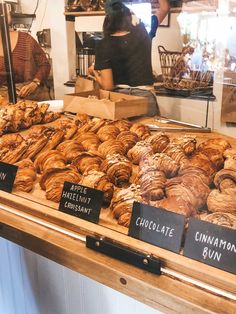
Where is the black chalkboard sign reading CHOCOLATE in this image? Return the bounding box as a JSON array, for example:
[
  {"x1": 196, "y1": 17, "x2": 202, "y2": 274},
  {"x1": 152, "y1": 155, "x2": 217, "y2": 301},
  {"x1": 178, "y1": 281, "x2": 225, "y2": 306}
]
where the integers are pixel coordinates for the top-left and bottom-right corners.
[{"x1": 128, "y1": 202, "x2": 185, "y2": 253}]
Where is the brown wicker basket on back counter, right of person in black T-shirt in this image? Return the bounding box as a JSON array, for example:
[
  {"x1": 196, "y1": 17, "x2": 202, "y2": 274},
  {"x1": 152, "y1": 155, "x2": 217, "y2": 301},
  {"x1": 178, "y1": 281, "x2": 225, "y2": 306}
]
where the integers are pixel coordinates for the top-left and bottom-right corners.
[{"x1": 158, "y1": 46, "x2": 213, "y2": 90}]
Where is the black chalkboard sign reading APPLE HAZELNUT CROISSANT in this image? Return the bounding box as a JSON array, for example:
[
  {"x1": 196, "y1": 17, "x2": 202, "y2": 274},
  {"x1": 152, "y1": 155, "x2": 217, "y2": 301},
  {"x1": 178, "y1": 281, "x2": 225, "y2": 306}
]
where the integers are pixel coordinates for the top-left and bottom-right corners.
[{"x1": 59, "y1": 181, "x2": 103, "y2": 223}]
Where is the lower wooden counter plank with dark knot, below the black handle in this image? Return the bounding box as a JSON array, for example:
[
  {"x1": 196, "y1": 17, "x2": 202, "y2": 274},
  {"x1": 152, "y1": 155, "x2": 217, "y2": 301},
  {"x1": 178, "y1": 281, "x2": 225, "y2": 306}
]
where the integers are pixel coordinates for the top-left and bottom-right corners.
[{"x1": 0, "y1": 206, "x2": 236, "y2": 314}]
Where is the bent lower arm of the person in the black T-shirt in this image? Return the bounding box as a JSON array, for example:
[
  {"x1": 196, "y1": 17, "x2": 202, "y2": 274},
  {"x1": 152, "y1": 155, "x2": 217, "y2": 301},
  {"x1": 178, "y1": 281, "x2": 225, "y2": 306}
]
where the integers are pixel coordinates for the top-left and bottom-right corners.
[{"x1": 88, "y1": 65, "x2": 114, "y2": 90}]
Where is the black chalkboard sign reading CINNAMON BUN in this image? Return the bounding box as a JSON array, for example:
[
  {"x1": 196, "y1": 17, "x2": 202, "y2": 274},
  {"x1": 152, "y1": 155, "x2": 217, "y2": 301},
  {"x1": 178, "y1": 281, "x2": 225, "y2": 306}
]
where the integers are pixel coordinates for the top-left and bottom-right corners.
[{"x1": 184, "y1": 218, "x2": 236, "y2": 274}]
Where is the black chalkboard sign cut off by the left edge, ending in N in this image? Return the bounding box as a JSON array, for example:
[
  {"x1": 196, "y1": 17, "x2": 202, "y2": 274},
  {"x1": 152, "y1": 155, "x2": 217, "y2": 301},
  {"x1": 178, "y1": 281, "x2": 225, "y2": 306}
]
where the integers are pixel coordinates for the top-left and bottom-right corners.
[{"x1": 0, "y1": 162, "x2": 18, "y2": 192}]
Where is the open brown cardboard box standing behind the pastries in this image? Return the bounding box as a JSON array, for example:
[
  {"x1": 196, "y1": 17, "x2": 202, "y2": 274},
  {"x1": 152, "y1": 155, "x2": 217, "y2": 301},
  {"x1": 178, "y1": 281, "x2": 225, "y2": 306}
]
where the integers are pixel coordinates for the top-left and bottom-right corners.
[{"x1": 64, "y1": 89, "x2": 148, "y2": 120}]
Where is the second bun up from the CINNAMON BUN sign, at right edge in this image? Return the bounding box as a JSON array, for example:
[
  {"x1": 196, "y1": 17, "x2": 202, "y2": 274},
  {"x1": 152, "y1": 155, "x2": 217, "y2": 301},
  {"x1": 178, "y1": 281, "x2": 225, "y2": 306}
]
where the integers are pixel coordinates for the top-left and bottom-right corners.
[{"x1": 207, "y1": 189, "x2": 236, "y2": 214}]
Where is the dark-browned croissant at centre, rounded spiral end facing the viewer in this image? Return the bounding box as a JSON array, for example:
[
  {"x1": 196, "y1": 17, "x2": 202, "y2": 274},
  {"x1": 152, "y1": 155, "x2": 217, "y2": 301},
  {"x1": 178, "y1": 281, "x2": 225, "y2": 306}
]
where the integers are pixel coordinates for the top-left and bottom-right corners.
[{"x1": 101, "y1": 154, "x2": 132, "y2": 187}]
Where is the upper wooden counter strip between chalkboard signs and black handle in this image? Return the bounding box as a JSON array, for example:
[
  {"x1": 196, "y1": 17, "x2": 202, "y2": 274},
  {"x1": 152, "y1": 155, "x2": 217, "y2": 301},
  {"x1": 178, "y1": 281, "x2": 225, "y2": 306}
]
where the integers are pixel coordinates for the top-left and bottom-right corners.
[{"x1": 0, "y1": 191, "x2": 236, "y2": 293}]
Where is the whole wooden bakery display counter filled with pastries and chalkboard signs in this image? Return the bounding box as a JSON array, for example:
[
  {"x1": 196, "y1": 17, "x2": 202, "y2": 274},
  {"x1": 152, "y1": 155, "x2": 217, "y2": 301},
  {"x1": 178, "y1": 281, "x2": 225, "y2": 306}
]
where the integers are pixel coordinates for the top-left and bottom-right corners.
[{"x1": 0, "y1": 1, "x2": 236, "y2": 313}]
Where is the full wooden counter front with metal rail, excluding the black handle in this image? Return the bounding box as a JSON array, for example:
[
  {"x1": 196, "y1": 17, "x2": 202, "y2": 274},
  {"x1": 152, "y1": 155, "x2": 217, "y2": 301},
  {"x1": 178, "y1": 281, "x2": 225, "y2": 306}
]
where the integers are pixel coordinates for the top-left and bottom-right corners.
[{"x1": 0, "y1": 118, "x2": 236, "y2": 314}]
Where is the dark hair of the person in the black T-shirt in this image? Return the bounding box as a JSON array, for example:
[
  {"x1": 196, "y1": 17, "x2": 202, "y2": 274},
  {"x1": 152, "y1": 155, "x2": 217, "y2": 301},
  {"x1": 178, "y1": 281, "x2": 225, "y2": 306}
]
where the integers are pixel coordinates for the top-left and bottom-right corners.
[{"x1": 103, "y1": 2, "x2": 132, "y2": 36}]
